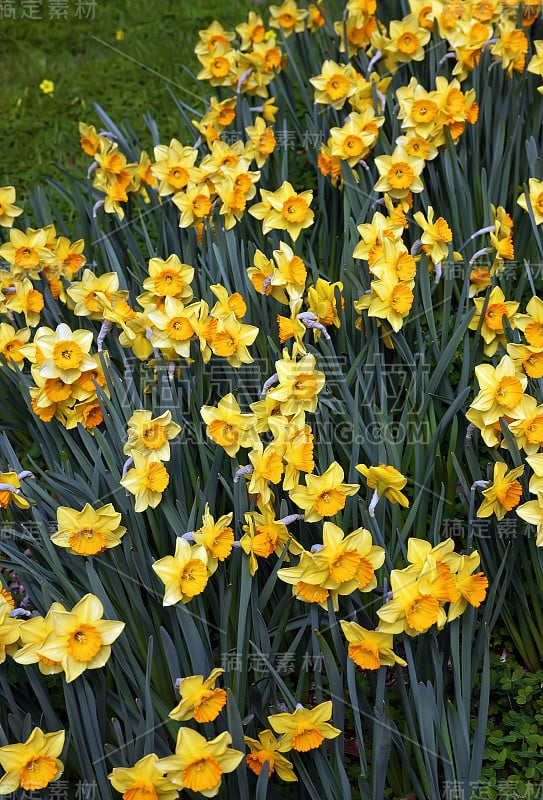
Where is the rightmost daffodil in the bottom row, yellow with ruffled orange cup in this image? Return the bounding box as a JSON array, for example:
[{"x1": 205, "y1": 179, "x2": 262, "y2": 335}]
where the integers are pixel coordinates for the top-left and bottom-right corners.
[{"x1": 268, "y1": 700, "x2": 341, "y2": 753}]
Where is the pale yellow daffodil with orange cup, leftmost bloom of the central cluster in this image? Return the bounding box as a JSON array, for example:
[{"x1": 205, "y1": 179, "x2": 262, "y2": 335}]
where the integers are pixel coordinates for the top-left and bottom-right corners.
[{"x1": 200, "y1": 394, "x2": 258, "y2": 456}]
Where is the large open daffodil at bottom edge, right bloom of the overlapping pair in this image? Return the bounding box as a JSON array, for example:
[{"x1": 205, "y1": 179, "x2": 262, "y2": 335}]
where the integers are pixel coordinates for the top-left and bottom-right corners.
[{"x1": 158, "y1": 728, "x2": 244, "y2": 797}]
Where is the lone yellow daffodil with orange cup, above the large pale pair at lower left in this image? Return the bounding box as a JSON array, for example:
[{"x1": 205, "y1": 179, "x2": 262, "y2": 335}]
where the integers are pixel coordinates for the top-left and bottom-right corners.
[{"x1": 51, "y1": 503, "x2": 126, "y2": 556}]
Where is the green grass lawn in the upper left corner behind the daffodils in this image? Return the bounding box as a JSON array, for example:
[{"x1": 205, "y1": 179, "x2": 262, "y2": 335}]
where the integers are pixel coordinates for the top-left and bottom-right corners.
[{"x1": 0, "y1": 0, "x2": 252, "y2": 200}]
